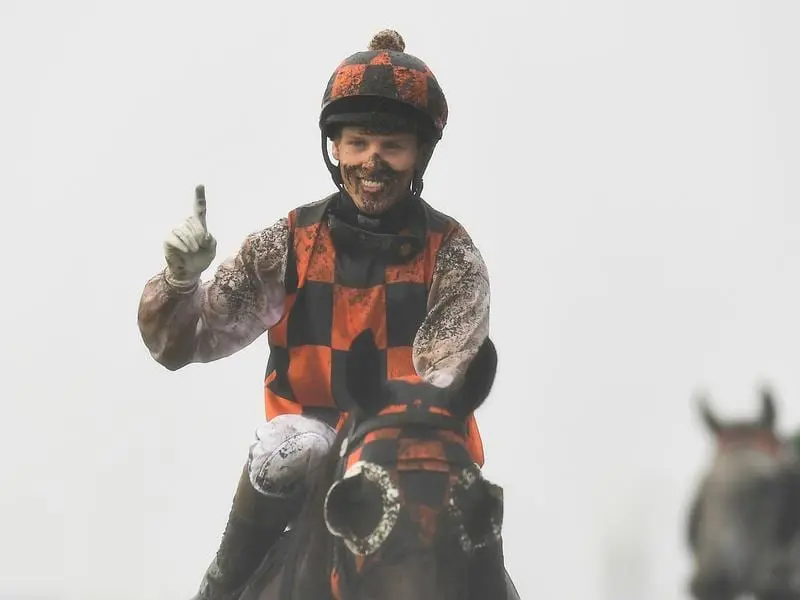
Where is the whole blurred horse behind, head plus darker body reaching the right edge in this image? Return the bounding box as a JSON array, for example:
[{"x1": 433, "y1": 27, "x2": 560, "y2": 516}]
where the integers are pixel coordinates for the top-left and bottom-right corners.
[{"x1": 688, "y1": 388, "x2": 800, "y2": 600}]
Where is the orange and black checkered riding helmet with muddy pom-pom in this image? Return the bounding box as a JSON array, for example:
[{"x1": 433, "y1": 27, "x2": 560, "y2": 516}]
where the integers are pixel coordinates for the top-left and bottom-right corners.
[{"x1": 319, "y1": 30, "x2": 447, "y2": 190}]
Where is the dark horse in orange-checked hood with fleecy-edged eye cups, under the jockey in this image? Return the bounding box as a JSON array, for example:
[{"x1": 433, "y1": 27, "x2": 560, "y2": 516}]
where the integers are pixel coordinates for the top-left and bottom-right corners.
[{"x1": 239, "y1": 330, "x2": 519, "y2": 600}]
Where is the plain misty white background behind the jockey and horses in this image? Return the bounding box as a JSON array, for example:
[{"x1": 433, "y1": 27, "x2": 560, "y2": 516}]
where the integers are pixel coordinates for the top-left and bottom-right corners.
[{"x1": 0, "y1": 0, "x2": 800, "y2": 600}]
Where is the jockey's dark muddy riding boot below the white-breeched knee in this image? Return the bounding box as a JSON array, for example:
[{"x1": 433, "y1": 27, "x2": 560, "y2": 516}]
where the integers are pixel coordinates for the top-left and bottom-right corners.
[{"x1": 192, "y1": 467, "x2": 296, "y2": 600}]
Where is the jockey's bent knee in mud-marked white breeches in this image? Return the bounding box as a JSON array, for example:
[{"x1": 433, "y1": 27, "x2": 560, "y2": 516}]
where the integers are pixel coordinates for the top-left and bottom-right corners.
[{"x1": 247, "y1": 415, "x2": 336, "y2": 497}]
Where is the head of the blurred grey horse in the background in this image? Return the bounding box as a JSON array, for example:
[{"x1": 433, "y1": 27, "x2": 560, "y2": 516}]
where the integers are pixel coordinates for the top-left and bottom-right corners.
[{"x1": 688, "y1": 388, "x2": 785, "y2": 600}]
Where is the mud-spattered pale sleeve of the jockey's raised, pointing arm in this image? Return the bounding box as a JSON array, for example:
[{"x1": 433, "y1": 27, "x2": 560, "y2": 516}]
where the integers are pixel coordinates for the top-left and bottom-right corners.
[{"x1": 138, "y1": 218, "x2": 288, "y2": 371}]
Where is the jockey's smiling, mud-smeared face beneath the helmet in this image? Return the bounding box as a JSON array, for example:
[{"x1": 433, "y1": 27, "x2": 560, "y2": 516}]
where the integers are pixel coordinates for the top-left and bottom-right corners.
[{"x1": 333, "y1": 126, "x2": 420, "y2": 215}]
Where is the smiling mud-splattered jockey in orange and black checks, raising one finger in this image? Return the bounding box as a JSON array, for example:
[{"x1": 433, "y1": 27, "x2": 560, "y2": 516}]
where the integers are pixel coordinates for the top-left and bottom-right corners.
[{"x1": 138, "y1": 30, "x2": 489, "y2": 600}]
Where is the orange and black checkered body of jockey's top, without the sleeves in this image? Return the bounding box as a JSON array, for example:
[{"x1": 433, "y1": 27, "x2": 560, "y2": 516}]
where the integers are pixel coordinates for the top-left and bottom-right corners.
[{"x1": 264, "y1": 196, "x2": 484, "y2": 465}]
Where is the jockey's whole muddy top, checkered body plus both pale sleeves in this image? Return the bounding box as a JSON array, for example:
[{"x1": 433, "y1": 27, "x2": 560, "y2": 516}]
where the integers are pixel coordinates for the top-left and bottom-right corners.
[{"x1": 139, "y1": 196, "x2": 489, "y2": 465}]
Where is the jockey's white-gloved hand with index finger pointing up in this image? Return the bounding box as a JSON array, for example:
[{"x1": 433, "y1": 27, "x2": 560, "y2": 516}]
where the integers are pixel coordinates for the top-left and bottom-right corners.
[{"x1": 164, "y1": 185, "x2": 217, "y2": 289}]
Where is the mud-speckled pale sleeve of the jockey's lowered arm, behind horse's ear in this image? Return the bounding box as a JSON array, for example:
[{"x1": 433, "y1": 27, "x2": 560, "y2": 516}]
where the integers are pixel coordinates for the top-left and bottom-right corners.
[{"x1": 413, "y1": 227, "x2": 489, "y2": 386}]
